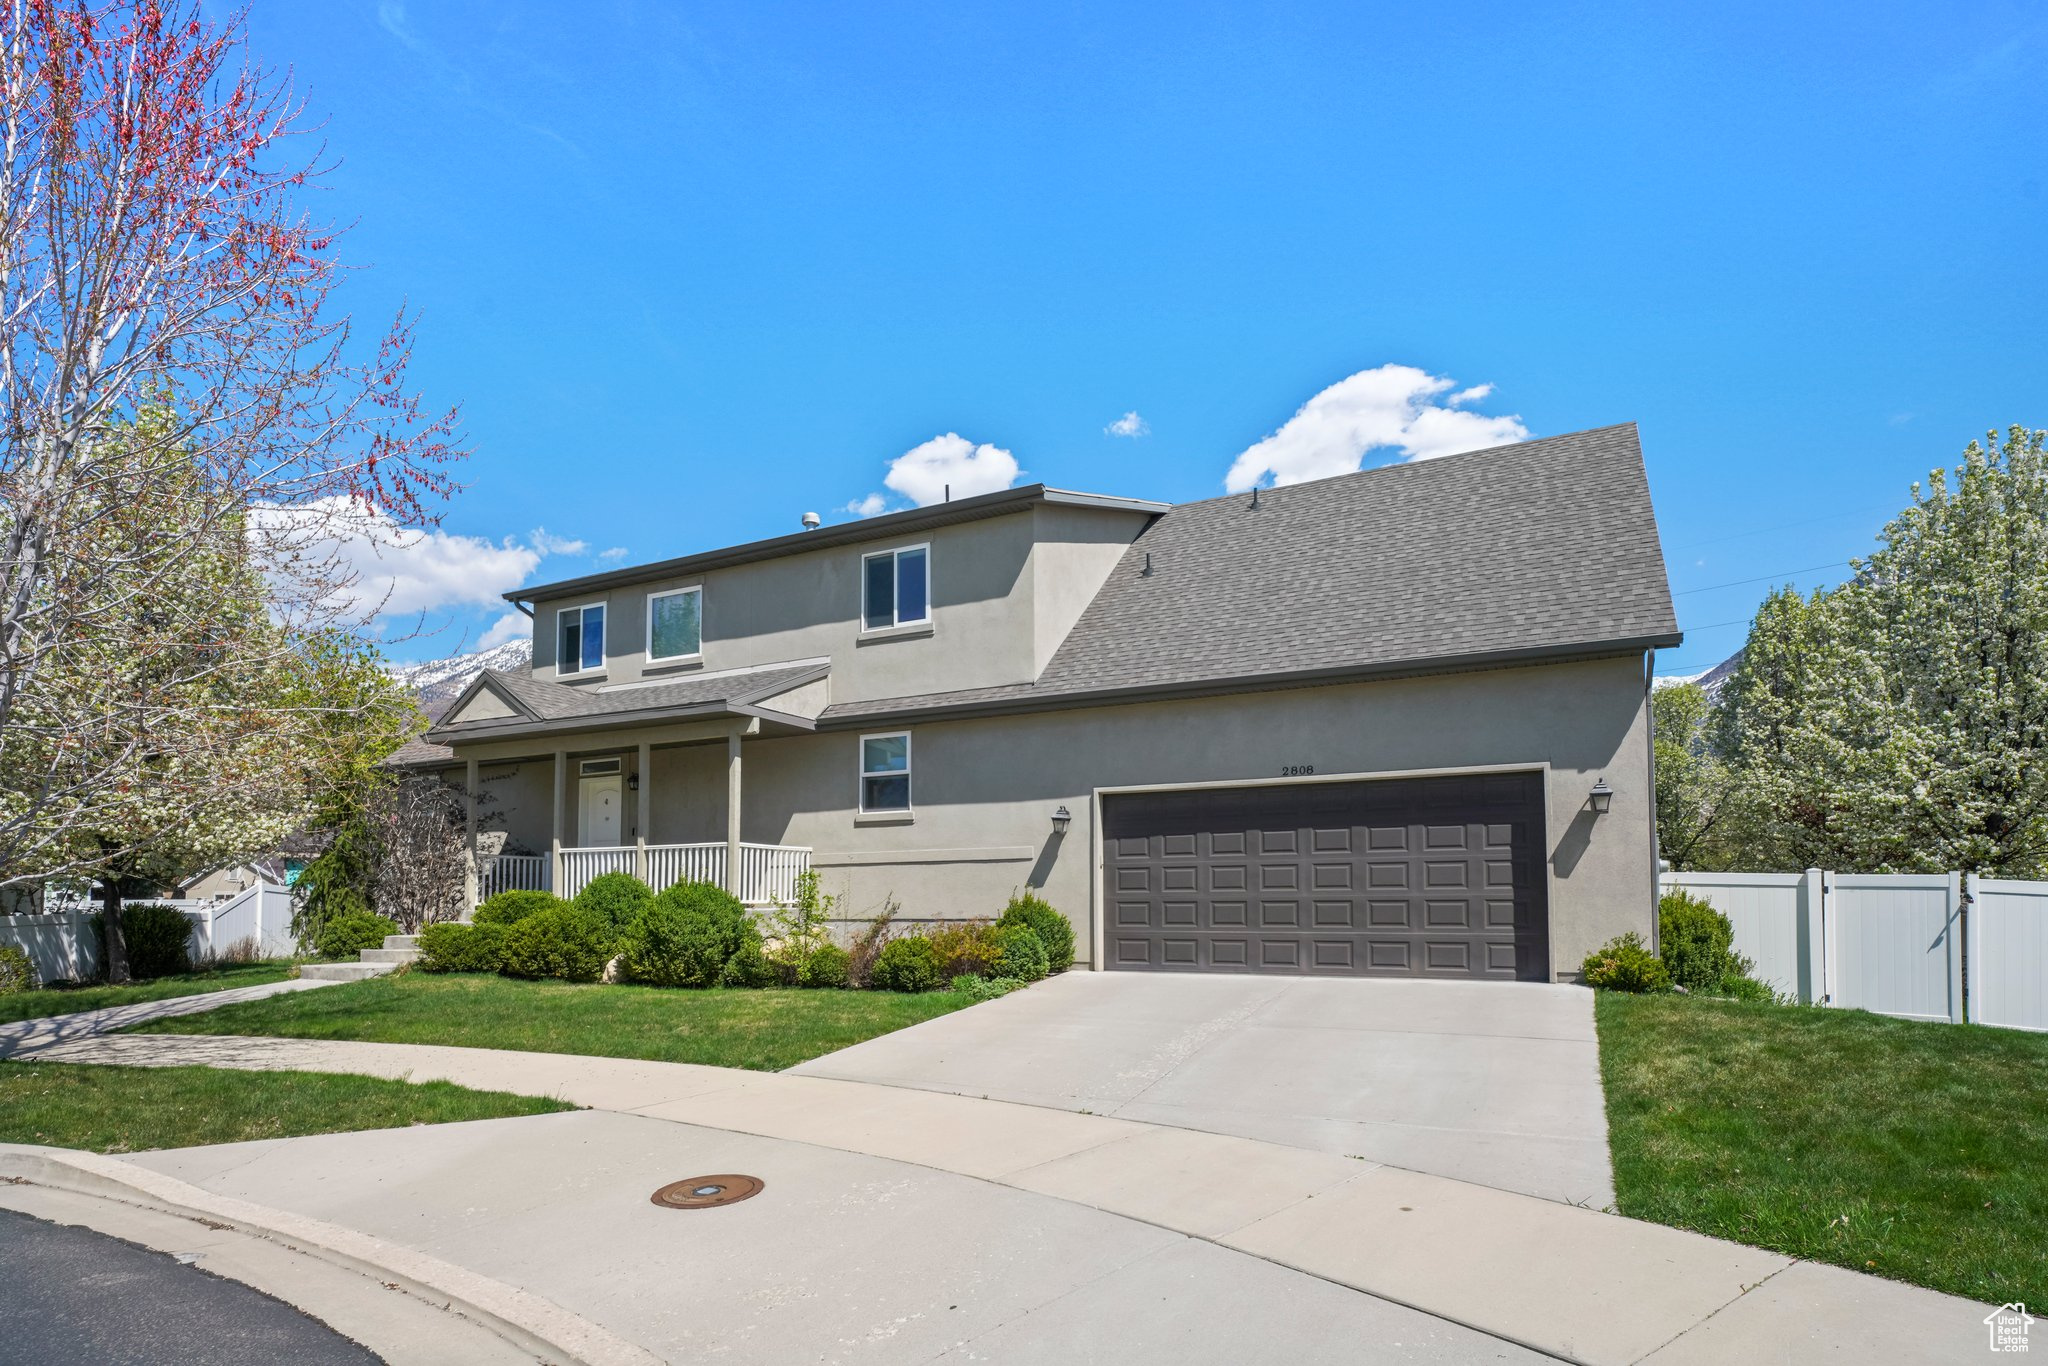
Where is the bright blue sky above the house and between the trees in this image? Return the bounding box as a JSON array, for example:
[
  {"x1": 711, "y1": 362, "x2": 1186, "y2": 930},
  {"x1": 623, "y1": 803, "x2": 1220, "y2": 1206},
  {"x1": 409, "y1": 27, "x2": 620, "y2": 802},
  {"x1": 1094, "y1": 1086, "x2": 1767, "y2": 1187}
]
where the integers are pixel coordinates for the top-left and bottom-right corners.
[{"x1": 252, "y1": 0, "x2": 2048, "y2": 672}]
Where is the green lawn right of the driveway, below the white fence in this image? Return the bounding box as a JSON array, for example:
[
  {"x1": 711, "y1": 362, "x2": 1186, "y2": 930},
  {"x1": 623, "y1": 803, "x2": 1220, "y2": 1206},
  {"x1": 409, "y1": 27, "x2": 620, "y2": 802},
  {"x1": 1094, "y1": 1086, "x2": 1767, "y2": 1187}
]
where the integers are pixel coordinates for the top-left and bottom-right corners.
[{"x1": 1595, "y1": 991, "x2": 2048, "y2": 1305}]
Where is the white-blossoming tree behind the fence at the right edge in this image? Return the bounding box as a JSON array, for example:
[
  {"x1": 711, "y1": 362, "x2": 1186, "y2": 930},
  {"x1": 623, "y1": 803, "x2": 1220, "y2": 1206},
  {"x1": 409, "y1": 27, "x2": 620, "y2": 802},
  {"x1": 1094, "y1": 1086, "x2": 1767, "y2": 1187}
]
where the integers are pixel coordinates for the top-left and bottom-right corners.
[{"x1": 1718, "y1": 426, "x2": 2048, "y2": 877}]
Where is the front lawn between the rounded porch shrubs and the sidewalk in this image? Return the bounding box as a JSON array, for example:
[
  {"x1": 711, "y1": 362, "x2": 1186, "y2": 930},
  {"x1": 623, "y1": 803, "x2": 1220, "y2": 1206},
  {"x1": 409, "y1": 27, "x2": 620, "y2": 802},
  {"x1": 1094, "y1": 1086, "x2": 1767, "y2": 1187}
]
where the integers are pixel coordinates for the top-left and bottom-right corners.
[{"x1": 137, "y1": 973, "x2": 973, "y2": 1071}]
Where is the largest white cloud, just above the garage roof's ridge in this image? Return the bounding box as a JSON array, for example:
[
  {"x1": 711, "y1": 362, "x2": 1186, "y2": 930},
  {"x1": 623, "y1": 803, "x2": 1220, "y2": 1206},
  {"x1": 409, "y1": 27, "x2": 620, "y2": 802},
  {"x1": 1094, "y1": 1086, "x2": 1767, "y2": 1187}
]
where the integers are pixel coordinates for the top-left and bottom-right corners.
[{"x1": 1223, "y1": 365, "x2": 1530, "y2": 494}]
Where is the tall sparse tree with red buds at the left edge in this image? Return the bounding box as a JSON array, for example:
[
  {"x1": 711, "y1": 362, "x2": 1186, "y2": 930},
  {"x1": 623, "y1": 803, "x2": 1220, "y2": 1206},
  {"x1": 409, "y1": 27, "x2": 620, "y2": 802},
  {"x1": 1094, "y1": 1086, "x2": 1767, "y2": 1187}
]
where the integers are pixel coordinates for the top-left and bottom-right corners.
[{"x1": 0, "y1": 0, "x2": 461, "y2": 970}]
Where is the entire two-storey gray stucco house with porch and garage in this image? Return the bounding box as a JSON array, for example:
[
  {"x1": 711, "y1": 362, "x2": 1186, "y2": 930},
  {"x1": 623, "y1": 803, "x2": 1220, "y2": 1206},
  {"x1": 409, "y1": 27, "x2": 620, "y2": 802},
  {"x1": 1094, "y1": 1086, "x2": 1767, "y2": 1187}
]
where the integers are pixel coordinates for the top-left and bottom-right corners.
[{"x1": 399, "y1": 426, "x2": 1679, "y2": 981}]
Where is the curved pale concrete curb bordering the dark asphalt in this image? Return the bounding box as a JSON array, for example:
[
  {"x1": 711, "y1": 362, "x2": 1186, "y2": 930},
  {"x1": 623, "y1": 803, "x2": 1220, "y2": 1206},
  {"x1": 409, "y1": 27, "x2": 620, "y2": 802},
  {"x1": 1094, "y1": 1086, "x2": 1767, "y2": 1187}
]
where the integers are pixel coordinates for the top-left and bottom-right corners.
[{"x1": 0, "y1": 1143, "x2": 662, "y2": 1366}]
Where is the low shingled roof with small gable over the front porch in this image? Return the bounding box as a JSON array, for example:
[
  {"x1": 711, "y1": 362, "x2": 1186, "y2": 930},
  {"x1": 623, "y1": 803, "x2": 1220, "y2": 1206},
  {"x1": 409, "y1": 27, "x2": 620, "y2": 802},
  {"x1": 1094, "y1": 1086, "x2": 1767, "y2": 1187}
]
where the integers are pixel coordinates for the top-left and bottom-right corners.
[{"x1": 423, "y1": 659, "x2": 831, "y2": 749}]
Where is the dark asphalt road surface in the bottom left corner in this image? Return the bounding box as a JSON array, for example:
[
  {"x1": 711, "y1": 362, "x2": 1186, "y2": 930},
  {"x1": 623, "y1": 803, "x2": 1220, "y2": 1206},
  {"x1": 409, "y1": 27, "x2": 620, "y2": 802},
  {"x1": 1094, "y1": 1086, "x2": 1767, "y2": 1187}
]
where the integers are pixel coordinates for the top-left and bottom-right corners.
[{"x1": 0, "y1": 1210, "x2": 383, "y2": 1366}]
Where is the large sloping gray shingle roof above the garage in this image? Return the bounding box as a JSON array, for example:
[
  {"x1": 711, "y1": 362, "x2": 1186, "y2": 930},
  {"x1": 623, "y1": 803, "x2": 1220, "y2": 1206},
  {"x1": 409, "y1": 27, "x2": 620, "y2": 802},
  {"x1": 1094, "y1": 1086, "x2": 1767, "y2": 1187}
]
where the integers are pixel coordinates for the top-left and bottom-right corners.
[{"x1": 819, "y1": 424, "x2": 1679, "y2": 723}]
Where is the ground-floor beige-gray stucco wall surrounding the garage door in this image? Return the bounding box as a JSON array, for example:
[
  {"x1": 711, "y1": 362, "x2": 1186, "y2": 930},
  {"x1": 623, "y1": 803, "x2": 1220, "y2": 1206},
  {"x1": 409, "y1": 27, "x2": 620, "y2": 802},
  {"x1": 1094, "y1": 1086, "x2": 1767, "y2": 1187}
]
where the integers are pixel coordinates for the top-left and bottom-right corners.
[{"x1": 456, "y1": 655, "x2": 1653, "y2": 977}]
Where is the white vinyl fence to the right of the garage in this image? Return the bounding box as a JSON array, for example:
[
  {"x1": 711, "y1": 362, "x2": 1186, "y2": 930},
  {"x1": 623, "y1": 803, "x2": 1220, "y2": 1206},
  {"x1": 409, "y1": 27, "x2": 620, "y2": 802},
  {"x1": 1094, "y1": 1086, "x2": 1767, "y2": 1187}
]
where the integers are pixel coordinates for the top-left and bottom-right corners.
[{"x1": 1663, "y1": 868, "x2": 2048, "y2": 1030}]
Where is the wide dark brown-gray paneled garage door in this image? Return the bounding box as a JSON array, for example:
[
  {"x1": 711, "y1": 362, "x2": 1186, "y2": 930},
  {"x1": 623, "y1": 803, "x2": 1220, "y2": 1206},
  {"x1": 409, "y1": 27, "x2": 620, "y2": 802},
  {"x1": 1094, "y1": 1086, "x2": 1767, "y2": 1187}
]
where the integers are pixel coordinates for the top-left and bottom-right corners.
[{"x1": 1102, "y1": 774, "x2": 1550, "y2": 981}]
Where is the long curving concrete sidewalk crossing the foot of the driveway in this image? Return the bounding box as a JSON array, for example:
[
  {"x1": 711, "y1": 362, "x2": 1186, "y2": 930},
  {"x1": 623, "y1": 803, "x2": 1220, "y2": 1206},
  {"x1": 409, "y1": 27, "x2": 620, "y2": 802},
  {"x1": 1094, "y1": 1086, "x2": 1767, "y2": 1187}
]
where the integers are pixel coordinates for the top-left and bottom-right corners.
[{"x1": 19, "y1": 1036, "x2": 1985, "y2": 1366}]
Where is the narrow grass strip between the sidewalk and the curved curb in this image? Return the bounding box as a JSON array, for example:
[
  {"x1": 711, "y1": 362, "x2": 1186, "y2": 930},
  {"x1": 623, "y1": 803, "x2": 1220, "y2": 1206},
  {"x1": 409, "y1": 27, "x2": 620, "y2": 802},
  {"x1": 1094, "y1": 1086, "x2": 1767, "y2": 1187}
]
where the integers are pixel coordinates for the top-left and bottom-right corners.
[{"x1": 0, "y1": 1063, "x2": 575, "y2": 1153}]
